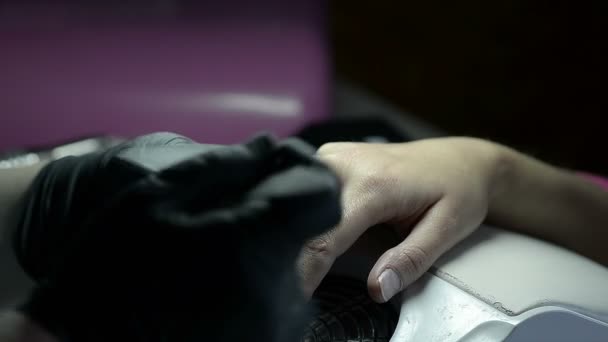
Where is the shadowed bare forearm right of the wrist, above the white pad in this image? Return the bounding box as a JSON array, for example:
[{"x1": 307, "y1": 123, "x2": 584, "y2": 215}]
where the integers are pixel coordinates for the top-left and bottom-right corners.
[{"x1": 488, "y1": 146, "x2": 608, "y2": 265}]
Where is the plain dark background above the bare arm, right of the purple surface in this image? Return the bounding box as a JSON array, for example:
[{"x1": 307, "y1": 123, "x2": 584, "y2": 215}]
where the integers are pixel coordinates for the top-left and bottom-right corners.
[{"x1": 330, "y1": 0, "x2": 608, "y2": 173}]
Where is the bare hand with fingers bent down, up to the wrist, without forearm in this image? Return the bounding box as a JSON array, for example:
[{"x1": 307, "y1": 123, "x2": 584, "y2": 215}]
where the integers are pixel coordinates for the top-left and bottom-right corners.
[{"x1": 298, "y1": 138, "x2": 496, "y2": 302}]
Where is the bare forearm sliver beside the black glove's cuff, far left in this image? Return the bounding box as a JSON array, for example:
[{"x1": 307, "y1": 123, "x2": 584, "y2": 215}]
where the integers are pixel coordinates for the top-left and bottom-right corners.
[{"x1": 0, "y1": 163, "x2": 44, "y2": 243}]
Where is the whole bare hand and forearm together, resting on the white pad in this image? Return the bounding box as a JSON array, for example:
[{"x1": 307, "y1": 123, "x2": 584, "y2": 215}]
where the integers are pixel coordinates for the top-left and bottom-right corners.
[{"x1": 298, "y1": 138, "x2": 608, "y2": 302}]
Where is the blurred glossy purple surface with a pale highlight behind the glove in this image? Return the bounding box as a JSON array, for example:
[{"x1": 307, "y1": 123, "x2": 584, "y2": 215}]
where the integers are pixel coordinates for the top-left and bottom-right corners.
[{"x1": 0, "y1": 1, "x2": 329, "y2": 149}]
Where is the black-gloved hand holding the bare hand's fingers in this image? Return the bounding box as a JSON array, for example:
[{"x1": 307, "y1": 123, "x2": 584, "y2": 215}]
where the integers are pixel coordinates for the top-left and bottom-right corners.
[{"x1": 14, "y1": 133, "x2": 340, "y2": 341}]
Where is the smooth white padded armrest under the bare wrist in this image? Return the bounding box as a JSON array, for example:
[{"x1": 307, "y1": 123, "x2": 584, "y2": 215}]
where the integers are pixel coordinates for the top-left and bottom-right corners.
[{"x1": 432, "y1": 227, "x2": 608, "y2": 318}]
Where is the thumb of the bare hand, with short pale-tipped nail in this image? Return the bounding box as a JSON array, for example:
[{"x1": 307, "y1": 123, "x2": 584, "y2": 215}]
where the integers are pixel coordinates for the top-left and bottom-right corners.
[{"x1": 367, "y1": 201, "x2": 472, "y2": 303}]
